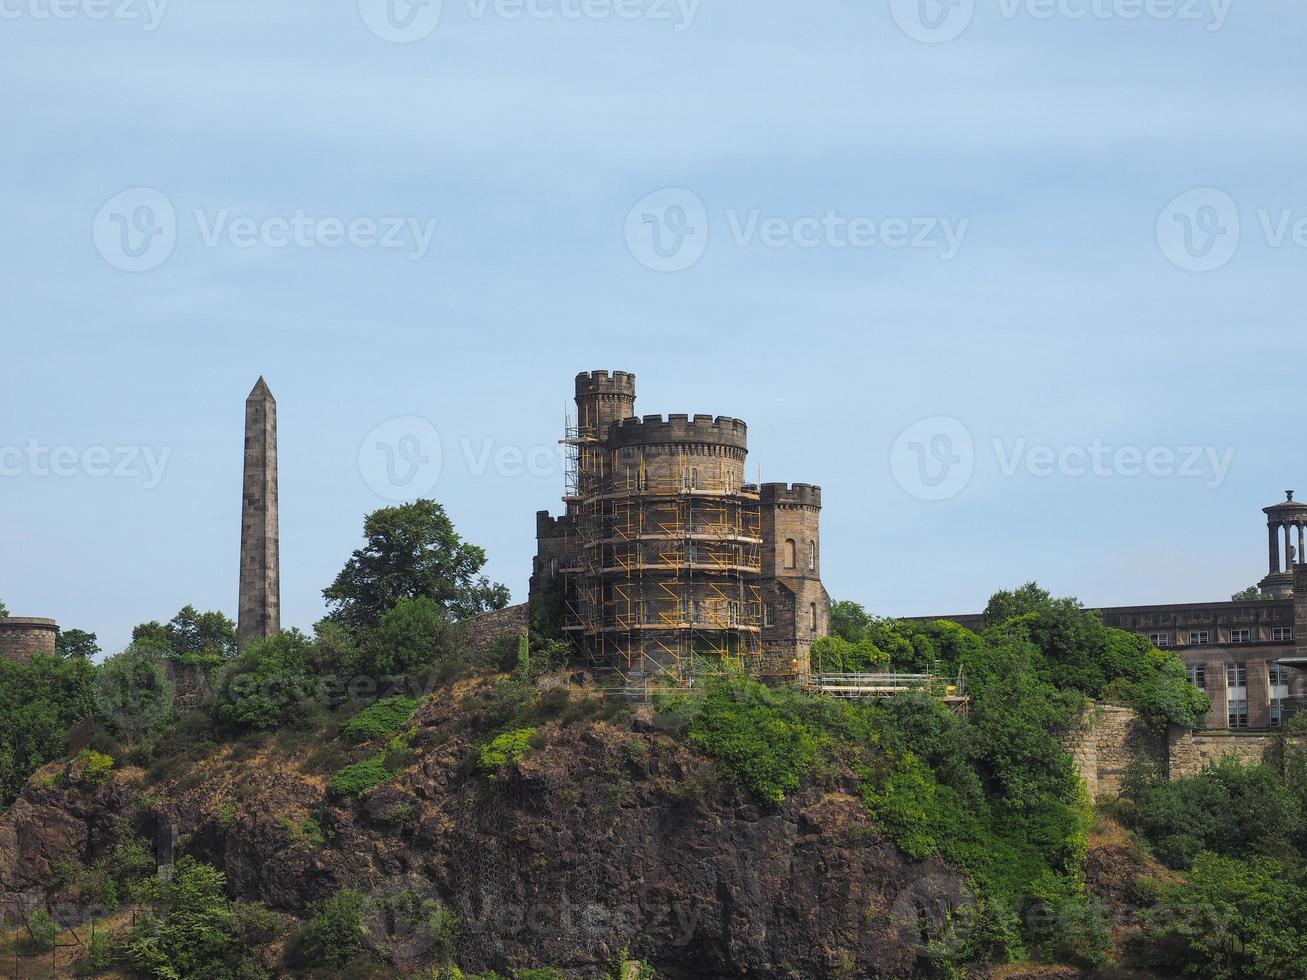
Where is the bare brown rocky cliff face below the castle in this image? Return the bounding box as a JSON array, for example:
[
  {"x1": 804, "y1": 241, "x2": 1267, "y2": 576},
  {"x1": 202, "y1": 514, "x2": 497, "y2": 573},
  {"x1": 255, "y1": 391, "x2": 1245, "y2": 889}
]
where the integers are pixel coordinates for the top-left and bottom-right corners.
[{"x1": 0, "y1": 679, "x2": 966, "y2": 980}]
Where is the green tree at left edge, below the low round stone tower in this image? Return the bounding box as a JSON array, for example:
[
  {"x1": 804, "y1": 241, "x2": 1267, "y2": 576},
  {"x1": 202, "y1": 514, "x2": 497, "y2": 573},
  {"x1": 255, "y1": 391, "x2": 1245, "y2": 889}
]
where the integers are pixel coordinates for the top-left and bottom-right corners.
[{"x1": 0, "y1": 655, "x2": 95, "y2": 809}]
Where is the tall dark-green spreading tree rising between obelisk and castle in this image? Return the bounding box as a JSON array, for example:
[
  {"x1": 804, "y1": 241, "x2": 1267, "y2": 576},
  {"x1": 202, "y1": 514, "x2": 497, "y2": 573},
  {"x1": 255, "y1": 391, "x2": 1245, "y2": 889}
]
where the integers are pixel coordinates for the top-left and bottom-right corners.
[{"x1": 323, "y1": 500, "x2": 508, "y2": 627}]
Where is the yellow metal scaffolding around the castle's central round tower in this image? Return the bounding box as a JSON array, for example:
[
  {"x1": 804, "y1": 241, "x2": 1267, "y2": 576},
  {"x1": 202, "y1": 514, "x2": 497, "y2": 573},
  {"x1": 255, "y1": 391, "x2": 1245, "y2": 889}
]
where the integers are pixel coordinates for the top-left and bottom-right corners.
[{"x1": 565, "y1": 459, "x2": 763, "y2": 685}]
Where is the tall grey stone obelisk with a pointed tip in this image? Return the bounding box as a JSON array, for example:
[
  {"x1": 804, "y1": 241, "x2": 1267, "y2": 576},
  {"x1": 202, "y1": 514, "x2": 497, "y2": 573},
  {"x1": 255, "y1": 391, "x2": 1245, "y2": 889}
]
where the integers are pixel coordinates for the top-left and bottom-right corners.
[{"x1": 237, "y1": 378, "x2": 281, "y2": 648}]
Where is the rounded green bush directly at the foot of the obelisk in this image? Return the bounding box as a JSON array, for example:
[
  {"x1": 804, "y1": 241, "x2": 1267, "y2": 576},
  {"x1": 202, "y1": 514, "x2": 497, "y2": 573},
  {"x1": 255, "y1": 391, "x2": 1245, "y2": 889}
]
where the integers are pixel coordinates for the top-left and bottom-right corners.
[{"x1": 214, "y1": 630, "x2": 324, "y2": 732}]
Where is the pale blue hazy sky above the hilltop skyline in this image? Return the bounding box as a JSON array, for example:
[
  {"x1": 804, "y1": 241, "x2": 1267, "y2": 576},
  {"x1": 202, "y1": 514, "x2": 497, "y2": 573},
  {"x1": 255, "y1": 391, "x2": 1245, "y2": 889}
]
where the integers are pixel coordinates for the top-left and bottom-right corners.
[{"x1": 0, "y1": 0, "x2": 1307, "y2": 661}]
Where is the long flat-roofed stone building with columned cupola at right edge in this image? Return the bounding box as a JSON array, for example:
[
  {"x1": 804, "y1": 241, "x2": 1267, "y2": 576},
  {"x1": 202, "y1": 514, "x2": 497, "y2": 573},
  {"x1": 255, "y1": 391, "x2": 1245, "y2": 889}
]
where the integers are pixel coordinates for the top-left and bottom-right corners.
[{"x1": 918, "y1": 490, "x2": 1307, "y2": 732}]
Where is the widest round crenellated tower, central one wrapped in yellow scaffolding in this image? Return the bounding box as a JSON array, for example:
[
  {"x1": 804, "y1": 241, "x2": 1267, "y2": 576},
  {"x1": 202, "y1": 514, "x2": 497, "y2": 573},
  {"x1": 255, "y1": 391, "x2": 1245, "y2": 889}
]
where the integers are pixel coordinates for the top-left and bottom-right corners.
[{"x1": 583, "y1": 416, "x2": 762, "y2": 679}]
